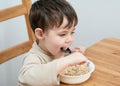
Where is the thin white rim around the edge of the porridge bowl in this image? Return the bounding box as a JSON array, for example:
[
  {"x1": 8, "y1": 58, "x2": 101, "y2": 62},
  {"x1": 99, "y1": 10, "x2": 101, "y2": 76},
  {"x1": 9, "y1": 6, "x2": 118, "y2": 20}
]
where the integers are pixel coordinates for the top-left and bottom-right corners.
[{"x1": 60, "y1": 60, "x2": 95, "y2": 77}]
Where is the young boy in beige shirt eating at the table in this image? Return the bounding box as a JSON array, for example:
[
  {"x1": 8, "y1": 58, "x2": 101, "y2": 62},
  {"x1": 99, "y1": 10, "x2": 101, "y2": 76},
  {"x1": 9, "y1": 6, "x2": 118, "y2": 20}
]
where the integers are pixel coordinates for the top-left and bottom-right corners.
[{"x1": 18, "y1": 0, "x2": 87, "y2": 86}]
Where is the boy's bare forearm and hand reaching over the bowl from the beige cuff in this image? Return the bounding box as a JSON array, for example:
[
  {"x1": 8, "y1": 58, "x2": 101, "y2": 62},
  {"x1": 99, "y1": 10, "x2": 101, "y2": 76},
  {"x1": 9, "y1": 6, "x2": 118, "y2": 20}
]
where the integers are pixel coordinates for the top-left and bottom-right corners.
[{"x1": 57, "y1": 52, "x2": 88, "y2": 74}]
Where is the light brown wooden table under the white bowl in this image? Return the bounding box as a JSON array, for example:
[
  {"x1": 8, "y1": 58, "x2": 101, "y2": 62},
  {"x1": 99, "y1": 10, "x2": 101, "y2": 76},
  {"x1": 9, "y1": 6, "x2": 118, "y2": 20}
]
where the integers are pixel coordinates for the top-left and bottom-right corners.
[{"x1": 60, "y1": 38, "x2": 120, "y2": 86}]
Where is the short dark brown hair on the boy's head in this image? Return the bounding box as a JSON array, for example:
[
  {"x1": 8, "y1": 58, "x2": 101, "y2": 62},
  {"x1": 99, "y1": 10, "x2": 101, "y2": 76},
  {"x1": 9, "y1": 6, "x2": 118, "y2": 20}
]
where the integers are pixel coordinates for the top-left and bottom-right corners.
[{"x1": 29, "y1": 0, "x2": 78, "y2": 31}]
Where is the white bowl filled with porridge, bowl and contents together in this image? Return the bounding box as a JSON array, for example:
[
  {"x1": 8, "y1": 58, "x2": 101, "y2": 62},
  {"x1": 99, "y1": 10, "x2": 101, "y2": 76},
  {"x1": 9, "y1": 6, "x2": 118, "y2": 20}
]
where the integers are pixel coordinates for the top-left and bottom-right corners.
[{"x1": 60, "y1": 60, "x2": 95, "y2": 84}]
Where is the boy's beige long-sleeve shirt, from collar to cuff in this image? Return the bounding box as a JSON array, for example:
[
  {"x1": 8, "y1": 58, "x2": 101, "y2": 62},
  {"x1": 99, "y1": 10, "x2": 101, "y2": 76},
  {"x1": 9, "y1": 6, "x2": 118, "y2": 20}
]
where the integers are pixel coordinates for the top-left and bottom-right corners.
[{"x1": 18, "y1": 42, "x2": 59, "y2": 86}]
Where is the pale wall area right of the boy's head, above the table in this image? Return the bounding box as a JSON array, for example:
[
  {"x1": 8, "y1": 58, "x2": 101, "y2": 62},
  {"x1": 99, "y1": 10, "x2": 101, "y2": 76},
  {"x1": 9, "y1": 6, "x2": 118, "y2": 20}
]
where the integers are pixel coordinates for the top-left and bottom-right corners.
[{"x1": 68, "y1": 0, "x2": 120, "y2": 47}]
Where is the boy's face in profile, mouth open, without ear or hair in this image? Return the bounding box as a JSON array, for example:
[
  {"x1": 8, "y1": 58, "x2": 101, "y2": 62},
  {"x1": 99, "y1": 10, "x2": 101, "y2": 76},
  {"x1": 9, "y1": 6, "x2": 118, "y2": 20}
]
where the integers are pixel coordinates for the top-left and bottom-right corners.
[{"x1": 38, "y1": 18, "x2": 74, "y2": 58}]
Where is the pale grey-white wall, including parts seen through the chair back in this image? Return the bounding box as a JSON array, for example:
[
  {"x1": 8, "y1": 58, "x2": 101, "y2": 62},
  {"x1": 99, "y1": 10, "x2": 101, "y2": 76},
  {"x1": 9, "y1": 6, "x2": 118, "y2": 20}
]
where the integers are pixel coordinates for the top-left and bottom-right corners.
[{"x1": 0, "y1": 0, "x2": 120, "y2": 86}]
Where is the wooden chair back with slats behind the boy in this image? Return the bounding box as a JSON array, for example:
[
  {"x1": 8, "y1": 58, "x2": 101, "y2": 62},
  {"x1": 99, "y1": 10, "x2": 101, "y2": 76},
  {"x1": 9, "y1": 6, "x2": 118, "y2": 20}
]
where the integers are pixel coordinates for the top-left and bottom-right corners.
[{"x1": 0, "y1": 0, "x2": 34, "y2": 64}]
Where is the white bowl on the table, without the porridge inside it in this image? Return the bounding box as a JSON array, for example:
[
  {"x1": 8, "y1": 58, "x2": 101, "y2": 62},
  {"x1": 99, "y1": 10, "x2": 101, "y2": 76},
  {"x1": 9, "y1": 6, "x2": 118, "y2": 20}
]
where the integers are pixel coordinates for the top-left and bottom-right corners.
[{"x1": 60, "y1": 60, "x2": 95, "y2": 84}]
